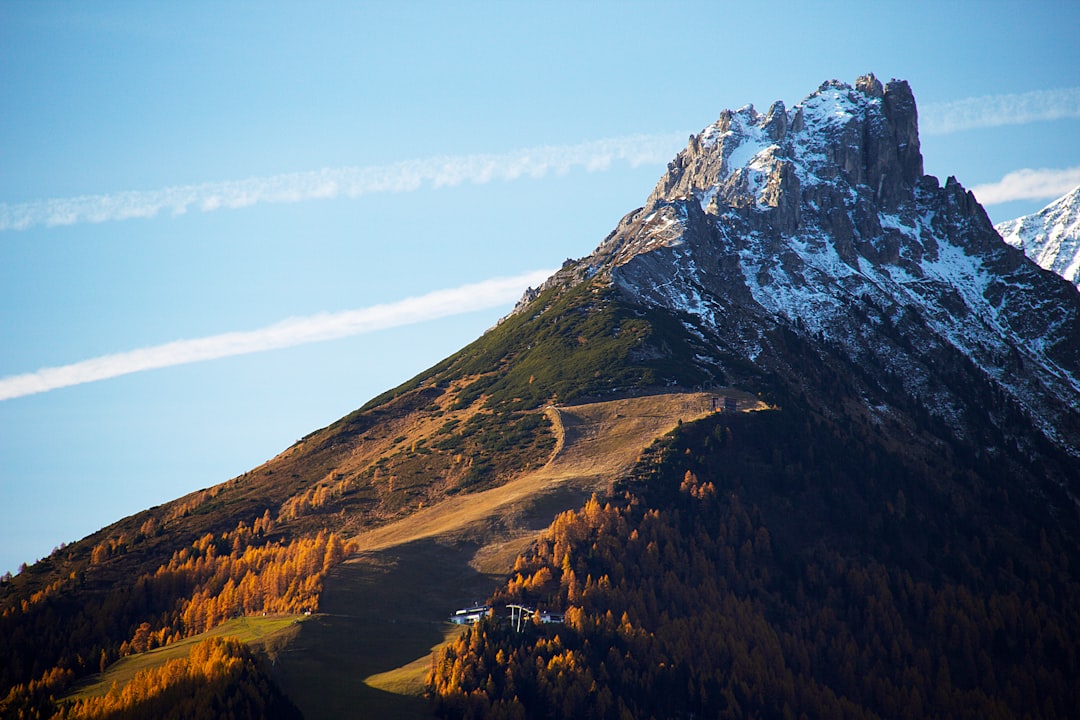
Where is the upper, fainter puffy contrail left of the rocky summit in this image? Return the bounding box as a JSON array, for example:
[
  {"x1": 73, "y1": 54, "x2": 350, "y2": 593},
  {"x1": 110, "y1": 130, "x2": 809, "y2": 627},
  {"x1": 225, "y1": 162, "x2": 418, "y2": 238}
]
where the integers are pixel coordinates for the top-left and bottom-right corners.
[{"x1": 0, "y1": 133, "x2": 686, "y2": 231}]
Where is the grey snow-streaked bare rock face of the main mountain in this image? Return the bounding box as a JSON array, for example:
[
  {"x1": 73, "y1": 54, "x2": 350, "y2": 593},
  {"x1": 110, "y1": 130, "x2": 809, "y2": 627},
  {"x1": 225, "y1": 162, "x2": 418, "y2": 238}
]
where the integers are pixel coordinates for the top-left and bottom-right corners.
[{"x1": 522, "y1": 74, "x2": 1080, "y2": 490}]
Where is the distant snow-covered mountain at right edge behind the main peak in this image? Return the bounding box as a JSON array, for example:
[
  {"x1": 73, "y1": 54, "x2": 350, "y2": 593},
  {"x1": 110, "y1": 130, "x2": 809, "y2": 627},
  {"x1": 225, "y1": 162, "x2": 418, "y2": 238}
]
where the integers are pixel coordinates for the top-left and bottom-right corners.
[{"x1": 995, "y1": 188, "x2": 1080, "y2": 286}]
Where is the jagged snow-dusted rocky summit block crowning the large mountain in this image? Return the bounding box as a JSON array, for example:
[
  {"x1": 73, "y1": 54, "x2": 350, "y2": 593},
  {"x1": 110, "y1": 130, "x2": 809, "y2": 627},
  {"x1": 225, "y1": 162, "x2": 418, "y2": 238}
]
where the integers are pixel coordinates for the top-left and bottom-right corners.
[{"x1": 650, "y1": 74, "x2": 922, "y2": 225}]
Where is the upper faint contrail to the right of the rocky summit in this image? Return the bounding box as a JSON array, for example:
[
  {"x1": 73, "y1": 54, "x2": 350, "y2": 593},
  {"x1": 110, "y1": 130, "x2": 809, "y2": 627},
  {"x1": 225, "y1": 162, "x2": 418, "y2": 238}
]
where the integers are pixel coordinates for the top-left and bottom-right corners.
[{"x1": 919, "y1": 87, "x2": 1080, "y2": 135}]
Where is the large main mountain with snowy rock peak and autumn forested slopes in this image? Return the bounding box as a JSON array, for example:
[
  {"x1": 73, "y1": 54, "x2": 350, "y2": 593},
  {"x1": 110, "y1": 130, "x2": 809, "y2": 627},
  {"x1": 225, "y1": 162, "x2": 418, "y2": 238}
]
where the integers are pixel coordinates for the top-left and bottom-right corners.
[{"x1": 0, "y1": 76, "x2": 1080, "y2": 718}]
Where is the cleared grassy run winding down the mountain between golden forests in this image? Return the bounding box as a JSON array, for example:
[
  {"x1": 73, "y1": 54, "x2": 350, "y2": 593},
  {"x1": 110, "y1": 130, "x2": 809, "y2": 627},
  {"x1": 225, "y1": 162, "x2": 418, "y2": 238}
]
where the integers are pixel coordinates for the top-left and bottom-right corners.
[{"x1": 52, "y1": 391, "x2": 764, "y2": 718}]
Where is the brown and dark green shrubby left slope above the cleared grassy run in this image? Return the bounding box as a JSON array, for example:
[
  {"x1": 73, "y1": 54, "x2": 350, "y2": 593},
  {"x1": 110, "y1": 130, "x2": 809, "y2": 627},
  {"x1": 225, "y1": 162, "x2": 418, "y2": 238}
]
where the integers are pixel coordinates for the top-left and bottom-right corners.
[{"x1": 0, "y1": 284, "x2": 695, "y2": 617}]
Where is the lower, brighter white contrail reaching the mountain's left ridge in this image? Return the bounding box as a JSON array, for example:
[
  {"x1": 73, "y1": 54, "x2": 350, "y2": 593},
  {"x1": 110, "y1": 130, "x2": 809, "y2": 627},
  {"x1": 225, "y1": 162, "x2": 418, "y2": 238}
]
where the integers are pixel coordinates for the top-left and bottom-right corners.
[{"x1": 0, "y1": 270, "x2": 552, "y2": 400}]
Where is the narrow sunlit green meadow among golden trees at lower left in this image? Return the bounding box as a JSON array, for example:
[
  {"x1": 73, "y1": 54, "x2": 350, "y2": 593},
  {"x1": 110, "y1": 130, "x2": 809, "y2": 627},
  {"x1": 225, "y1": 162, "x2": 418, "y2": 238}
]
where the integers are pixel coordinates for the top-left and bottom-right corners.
[{"x1": 63, "y1": 615, "x2": 307, "y2": 699}]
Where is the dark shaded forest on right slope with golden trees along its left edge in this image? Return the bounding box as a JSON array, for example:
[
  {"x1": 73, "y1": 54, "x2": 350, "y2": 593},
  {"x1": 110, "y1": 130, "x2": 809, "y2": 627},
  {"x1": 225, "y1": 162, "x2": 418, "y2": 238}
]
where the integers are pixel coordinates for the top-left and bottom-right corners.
[{"x1": 430, "y1": 412, "x2": 1080, "y2": 719}]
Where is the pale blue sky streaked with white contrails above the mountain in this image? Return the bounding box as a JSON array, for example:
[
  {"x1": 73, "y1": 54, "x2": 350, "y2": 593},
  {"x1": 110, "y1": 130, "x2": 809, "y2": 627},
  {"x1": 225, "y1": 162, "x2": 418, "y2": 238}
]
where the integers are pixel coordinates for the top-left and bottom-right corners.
[{"x1": 0, "y1": 1, "x2": 1080, "y2": 572}]
